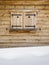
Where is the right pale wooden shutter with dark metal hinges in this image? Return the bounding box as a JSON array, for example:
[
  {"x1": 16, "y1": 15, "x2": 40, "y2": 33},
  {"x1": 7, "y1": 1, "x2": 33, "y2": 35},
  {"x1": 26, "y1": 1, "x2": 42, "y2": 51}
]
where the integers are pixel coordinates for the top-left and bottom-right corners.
[{"x1": 24, "y1": 12, "x2": 36, "y2": 27}]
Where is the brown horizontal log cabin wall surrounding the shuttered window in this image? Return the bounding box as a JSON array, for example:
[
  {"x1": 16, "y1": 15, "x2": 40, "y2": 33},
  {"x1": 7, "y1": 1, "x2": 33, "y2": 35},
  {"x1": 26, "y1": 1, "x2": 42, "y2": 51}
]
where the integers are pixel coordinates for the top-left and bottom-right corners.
[{"x1": 0, "y1": 0, "x2": 49, "y2": 47}]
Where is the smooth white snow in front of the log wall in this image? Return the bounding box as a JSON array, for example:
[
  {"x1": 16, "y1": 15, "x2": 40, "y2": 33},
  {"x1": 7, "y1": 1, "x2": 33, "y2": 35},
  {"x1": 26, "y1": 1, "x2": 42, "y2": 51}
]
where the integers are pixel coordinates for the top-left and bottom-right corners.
[{"x1": 0, "y1": 46, "x2": 49, "y2": 65}]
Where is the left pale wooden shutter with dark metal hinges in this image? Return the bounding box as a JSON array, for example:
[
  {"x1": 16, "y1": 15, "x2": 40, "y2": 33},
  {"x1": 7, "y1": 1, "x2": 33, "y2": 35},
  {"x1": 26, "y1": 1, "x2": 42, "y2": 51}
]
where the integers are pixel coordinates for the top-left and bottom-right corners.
[{"x1": 11, "y1": 13, "x2": 22, "y2": 27}]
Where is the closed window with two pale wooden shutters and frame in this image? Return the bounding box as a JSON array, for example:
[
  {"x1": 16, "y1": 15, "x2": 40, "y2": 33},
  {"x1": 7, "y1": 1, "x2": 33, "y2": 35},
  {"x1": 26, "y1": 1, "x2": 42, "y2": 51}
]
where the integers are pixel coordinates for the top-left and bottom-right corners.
[{"x1": 11, "y1": 11, "x2": 36, "y2": 30}]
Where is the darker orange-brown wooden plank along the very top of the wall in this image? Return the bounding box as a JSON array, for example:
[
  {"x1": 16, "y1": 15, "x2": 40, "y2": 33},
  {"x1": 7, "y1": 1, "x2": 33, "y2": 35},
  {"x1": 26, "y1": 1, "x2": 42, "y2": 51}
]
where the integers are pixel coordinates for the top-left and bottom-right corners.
[{"x1": 0, "y1": 1, "x2": 49, "y2": 5}]
